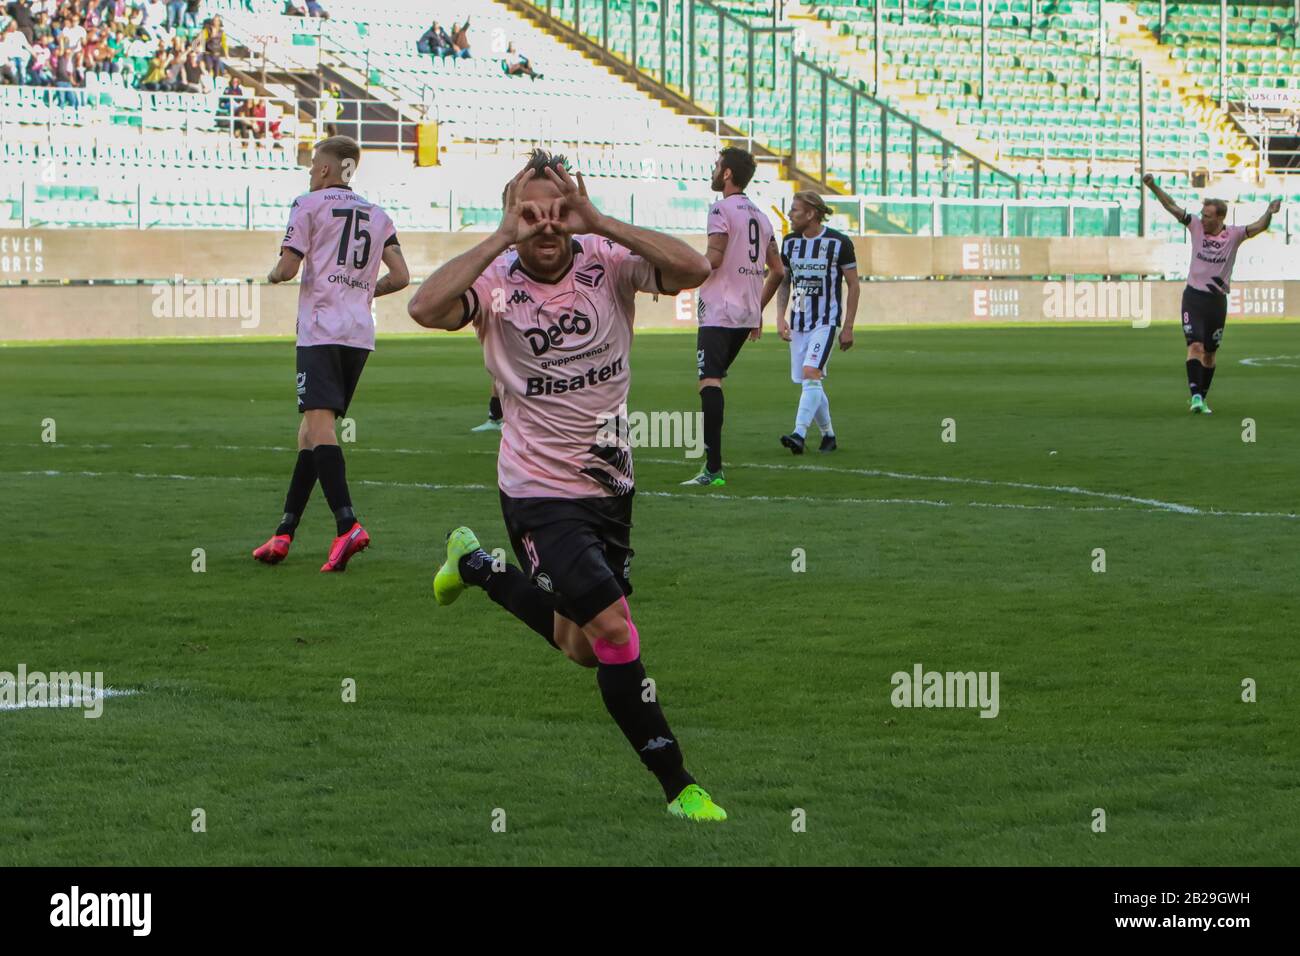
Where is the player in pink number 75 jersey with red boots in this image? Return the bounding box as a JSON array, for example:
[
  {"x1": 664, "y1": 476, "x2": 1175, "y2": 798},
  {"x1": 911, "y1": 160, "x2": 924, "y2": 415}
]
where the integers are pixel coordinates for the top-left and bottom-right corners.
[{"x1": 245, "y1": 137, "x2": 411, "y2": 571}]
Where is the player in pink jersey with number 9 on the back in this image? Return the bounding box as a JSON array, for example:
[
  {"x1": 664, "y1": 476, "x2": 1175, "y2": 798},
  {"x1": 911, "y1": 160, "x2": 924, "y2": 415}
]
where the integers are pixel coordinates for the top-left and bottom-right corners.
[{"x1": 681, "y1": 146, "x2": 785, "y2": 488}]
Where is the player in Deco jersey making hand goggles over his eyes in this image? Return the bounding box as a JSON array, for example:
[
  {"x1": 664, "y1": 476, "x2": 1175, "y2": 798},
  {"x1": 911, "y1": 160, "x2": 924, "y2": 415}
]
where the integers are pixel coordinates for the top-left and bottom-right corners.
[{"x1": 407, "y1": 150, "x2": 727, "y2": 821}]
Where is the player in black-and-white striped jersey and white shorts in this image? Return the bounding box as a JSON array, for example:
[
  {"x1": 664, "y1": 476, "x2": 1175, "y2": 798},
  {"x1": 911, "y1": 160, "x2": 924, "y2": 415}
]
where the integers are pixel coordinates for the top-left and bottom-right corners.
[{"x1": 763, "y1": 190, "x2": 859, "y2": 455}]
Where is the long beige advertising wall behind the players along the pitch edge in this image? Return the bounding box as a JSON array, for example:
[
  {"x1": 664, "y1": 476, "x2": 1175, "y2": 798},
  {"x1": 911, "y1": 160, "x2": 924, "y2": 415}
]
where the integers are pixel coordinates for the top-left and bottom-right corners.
[{"x1": 0, "y1": 230, "x2": 1300, "y2": 341}]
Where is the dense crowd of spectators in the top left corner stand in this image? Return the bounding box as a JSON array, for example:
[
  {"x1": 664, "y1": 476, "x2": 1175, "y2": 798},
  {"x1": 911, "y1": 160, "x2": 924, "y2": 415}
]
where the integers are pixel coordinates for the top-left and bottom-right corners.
[{"x1": 0, "y1": 0, "x2": 229, "y2": 92}]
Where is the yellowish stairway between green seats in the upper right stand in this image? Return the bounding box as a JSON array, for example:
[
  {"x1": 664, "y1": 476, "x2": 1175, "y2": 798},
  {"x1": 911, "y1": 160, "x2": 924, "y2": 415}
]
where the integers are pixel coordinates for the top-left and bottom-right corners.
[{"x1": 1104, "y1": 3, "x2": 1260, "y2": 168}]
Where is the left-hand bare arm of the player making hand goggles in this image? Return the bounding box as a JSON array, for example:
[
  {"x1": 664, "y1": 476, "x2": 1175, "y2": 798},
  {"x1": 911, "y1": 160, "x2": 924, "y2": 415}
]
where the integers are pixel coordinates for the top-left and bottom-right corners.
[{"x1": 407, "y1": 169, "x2": 547, "y2": 330}]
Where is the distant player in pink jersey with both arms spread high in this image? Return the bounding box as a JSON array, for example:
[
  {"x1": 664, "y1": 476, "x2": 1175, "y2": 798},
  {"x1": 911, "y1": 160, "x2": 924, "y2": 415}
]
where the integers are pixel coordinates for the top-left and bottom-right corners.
[{"x1": 1143, "y1": 173, "x2": 1282, "y2": 415}]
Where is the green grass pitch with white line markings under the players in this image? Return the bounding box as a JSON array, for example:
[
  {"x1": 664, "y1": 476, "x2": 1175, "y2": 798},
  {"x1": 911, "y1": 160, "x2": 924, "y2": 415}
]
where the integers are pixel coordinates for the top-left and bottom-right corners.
[{"x1": 0, "y1": 323, "x2": 1300, "y2": 866}]
